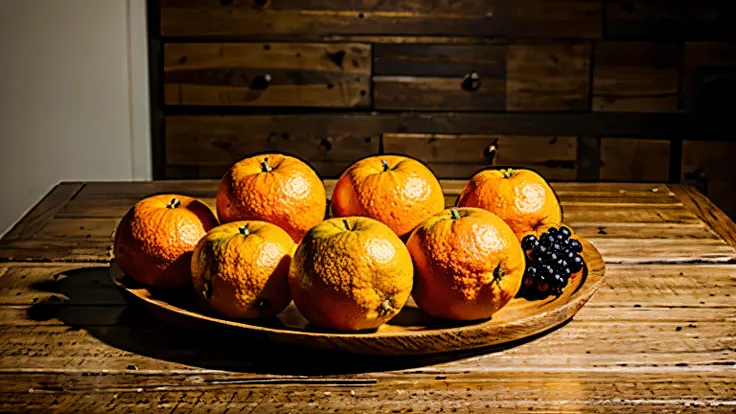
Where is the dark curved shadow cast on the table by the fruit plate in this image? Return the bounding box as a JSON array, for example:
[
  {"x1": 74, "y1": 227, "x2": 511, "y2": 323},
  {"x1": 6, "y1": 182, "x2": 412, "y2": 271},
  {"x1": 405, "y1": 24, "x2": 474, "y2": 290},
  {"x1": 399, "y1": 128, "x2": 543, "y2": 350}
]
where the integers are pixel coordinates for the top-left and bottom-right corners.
[{"x1": 23, "y1": 267, "x2": 559, "y2": 375}]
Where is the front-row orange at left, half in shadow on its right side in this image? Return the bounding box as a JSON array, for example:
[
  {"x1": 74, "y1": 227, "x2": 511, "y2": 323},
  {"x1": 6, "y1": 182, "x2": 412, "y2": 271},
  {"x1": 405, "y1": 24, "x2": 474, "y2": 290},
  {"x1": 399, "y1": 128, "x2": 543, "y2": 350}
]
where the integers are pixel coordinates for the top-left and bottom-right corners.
[{"x1": 191, "y1": 221, "x2": 296, "y2": 318}]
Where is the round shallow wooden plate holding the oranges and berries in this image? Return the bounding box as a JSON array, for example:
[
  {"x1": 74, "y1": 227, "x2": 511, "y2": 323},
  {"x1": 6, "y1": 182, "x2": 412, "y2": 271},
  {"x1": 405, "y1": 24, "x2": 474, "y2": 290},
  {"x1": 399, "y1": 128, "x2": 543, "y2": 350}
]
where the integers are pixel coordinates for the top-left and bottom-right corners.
[{"x1": 110, "y1": 238, "x2": 605, "y2": 355}]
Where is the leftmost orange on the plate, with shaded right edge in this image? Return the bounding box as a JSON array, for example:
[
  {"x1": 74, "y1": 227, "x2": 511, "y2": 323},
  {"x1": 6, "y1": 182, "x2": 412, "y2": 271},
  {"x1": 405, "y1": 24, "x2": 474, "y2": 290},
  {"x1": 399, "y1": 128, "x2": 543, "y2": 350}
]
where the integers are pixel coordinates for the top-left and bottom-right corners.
[{"x1": 114, "y1": 194, "x2": 217, "y2": 287}]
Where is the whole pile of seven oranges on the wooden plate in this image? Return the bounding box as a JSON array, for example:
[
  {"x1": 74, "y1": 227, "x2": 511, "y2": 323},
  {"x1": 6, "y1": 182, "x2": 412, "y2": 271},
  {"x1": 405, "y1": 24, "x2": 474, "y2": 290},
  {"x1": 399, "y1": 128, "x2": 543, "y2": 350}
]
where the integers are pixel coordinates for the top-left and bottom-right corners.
[{"x1": 114, "y1": 154, "x2": 576, "y2": 331}]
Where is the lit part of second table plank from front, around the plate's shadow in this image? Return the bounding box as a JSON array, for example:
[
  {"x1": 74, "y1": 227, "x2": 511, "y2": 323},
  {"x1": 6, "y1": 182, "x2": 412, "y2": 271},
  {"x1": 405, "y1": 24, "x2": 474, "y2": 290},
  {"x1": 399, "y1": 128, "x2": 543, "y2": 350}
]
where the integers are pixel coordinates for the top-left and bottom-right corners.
[{"x1": 0, "y1": 314, "x2": 736, "y2": 375}]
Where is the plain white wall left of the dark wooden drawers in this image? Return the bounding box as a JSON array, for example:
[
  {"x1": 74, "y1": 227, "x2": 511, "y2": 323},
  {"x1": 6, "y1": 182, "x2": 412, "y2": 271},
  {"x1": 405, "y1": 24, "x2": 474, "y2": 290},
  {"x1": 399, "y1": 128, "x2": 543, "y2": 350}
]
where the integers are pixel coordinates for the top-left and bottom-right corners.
[{"x1": 0, "y1": 0, "x2": 151, "y2": 233}]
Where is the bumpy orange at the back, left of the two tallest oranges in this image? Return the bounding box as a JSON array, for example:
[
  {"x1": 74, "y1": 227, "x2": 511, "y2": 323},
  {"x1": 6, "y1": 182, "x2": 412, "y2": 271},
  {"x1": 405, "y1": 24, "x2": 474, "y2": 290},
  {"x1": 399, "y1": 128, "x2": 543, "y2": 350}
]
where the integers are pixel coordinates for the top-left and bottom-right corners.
[{"x1": 217, "y1": 154, "x2": 327, "y2": 242}]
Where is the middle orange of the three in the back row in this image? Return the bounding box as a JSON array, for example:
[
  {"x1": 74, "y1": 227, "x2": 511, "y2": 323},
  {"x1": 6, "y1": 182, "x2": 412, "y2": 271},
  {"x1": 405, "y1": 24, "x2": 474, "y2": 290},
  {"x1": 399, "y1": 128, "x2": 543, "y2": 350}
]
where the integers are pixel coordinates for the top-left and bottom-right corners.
[{"x1": 331, "y1": 155, "x2": 445, "y2": 237}]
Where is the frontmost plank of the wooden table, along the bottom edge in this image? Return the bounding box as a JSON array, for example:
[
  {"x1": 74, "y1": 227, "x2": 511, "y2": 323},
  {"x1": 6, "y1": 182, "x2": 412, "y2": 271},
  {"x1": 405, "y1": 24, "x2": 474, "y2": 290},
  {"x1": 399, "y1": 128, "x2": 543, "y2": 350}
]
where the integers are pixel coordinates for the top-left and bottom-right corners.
[{"x1": 0, "y1": 372, "x2": 734, "y2": 414}]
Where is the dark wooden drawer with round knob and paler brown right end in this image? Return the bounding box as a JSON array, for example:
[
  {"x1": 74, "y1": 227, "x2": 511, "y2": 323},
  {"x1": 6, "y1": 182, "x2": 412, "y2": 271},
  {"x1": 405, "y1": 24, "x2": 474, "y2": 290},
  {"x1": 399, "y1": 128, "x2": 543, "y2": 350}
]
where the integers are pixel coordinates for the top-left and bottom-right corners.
[{"x1": 373, "y1": 42, "x2": 591, "y2": 111}]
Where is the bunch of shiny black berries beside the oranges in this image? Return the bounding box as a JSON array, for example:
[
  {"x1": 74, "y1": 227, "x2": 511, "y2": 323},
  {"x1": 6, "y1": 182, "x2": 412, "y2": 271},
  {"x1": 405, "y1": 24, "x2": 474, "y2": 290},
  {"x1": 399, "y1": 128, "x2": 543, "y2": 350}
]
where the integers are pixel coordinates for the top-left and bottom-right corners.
[{"x1": 519, "y1": 226, "x2": 584, "y2": 298}]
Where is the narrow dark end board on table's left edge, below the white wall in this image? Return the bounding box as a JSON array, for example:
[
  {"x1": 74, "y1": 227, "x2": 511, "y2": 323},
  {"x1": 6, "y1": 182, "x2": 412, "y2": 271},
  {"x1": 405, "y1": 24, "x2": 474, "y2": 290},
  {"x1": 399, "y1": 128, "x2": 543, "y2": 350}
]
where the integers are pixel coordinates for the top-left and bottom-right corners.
[{"x1": 3, "y1": 183, "x2": 84, "y2": 240}]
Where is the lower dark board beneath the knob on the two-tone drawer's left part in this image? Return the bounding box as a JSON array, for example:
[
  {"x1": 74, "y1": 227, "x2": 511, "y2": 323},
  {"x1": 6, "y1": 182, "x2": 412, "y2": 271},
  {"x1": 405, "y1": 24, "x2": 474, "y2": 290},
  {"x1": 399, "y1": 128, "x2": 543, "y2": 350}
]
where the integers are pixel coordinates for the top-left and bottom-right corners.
[{"x1": 373, "y1": 76, "x2": 506, "y2": 111}]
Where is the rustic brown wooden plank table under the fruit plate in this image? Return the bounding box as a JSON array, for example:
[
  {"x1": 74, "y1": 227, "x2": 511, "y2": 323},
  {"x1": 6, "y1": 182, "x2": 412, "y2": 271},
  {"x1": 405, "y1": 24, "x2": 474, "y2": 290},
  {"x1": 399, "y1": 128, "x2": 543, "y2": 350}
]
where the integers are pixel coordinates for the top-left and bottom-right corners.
[{"x1": 0, "y1": 181, "x2": 736, "y2": 413}]
